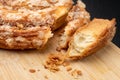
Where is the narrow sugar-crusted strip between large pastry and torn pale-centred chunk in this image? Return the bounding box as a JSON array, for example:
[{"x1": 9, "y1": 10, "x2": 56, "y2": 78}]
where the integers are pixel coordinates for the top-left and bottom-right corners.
[{"x1": 59, "y1": 0, "x2": 90, "y2": 49}]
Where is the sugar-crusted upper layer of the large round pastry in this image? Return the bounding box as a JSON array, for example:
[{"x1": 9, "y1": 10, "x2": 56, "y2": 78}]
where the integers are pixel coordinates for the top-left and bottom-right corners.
[{"x1": 0, "y1": 0, "x2": 72, "y2": 29}]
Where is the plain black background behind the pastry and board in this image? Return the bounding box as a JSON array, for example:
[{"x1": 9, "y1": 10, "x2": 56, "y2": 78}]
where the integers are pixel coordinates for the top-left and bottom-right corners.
[{"x1": 74, "y1": 0, "x2": 120, "y2": 47}]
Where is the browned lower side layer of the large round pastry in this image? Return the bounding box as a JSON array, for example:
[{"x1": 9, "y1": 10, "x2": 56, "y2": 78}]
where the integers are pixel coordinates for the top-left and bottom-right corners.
[{"x1": 0, "y1": 27, "x2": 52, "y2": 49}]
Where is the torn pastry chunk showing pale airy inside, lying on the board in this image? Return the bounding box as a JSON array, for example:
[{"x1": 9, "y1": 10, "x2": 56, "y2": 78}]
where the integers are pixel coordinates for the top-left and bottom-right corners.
[{"x1": 67, "y1": 19, "x2": 116, "y2": 59}]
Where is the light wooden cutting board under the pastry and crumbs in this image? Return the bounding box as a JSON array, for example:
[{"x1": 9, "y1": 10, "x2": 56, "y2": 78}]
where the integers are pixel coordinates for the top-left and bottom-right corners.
[{"x1": 0, "y1": 31, "x2": 120, "y2": 80}]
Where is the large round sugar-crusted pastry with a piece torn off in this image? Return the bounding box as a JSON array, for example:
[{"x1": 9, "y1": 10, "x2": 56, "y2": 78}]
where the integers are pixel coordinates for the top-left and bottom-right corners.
[{"x1": 0, "y1": 0, "x2": 72, "y2": 49}]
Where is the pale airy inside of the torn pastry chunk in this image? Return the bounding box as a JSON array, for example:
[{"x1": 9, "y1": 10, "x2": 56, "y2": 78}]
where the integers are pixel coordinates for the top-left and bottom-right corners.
[{"x1": 71, "y1": 33, "x2": 95, "y2": 56}]
